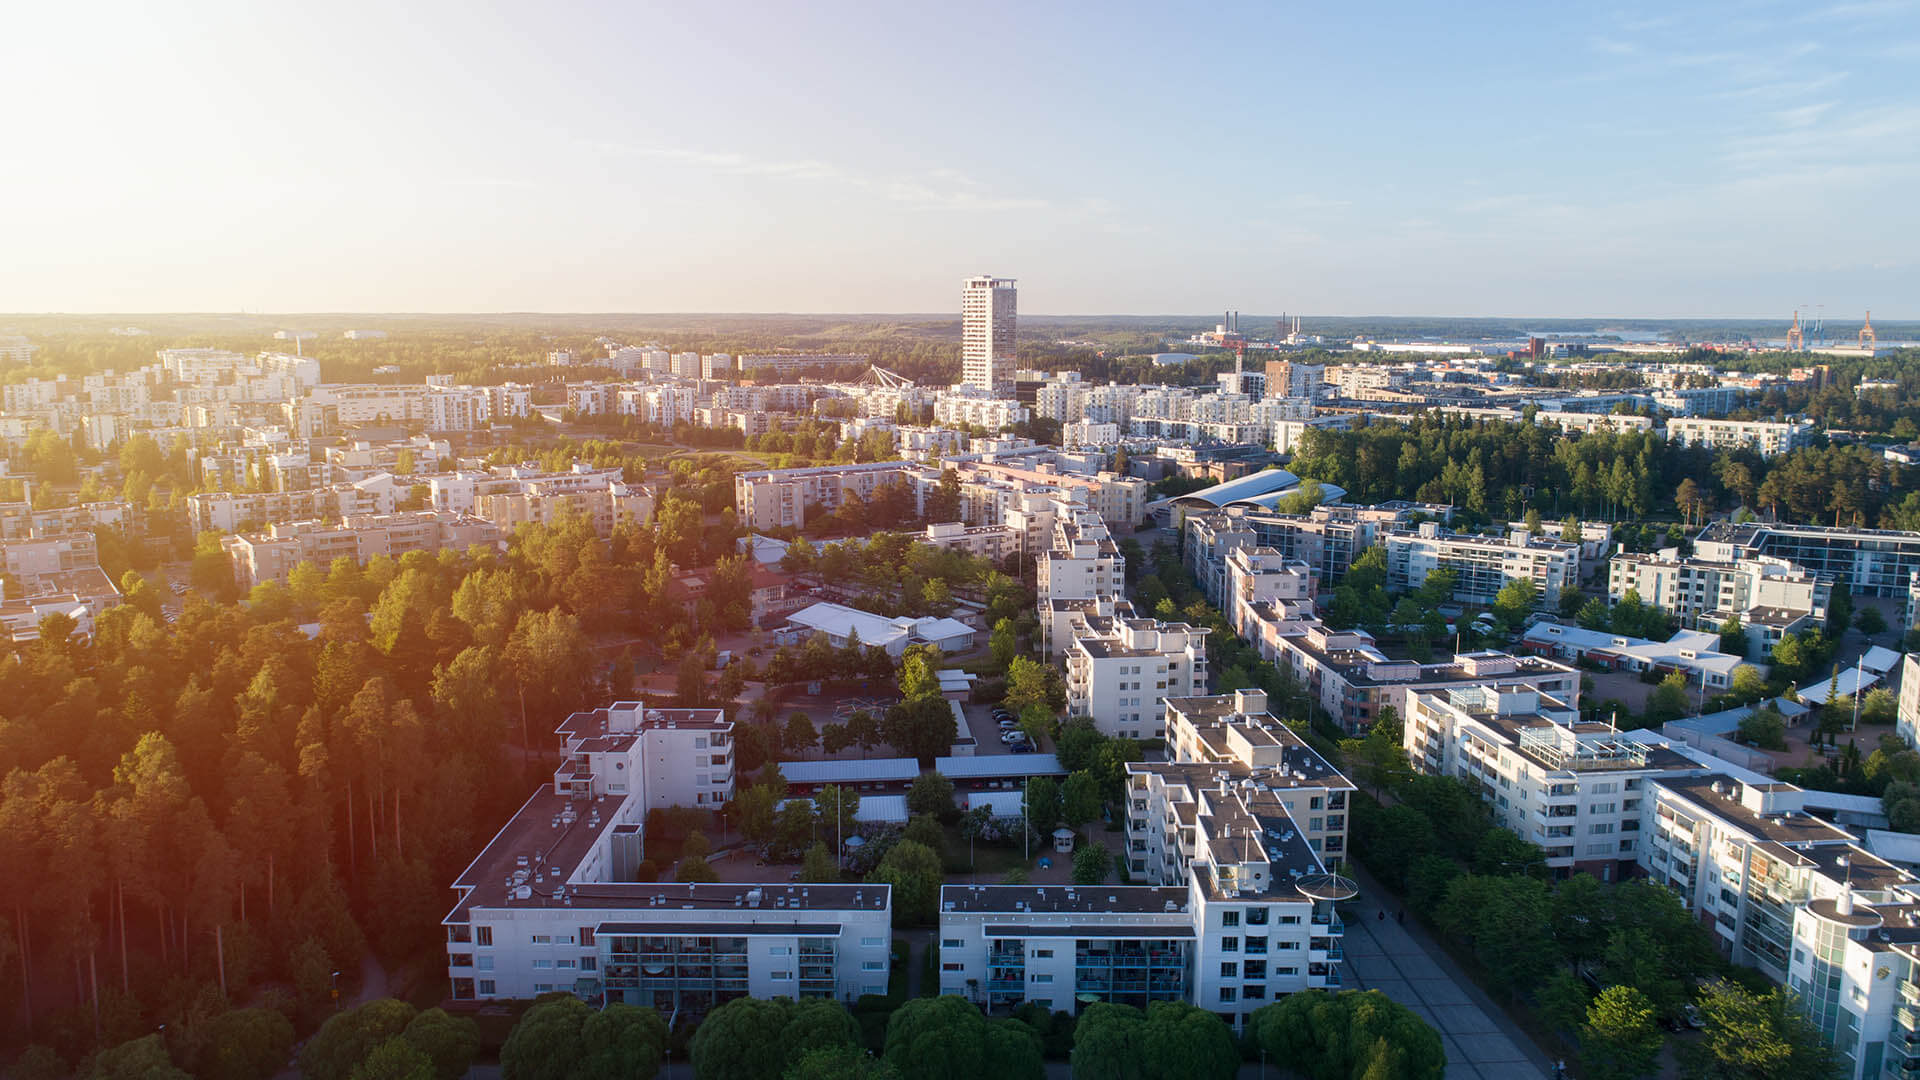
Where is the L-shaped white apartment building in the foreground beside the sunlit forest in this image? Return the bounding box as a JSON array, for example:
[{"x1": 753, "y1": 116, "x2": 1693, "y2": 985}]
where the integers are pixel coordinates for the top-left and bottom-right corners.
[{"x1": 444, "y1": 701, "x2": 893, "y2": 1015}]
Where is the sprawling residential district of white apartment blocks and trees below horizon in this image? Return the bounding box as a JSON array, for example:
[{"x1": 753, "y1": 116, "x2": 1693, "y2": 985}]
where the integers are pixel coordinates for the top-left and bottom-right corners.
[{"x1": 0, "y1": 292, "x2": 1920, "y2": 1080}]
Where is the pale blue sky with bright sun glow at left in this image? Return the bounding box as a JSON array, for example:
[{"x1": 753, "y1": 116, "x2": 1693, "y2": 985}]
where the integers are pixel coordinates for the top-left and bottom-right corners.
[{"x1": 0, "y1": 0, "x2": 1920, "y2": 315}]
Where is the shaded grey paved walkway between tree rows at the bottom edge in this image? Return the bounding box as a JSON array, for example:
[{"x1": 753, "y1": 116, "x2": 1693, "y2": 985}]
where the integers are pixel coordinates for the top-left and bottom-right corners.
[{"x1": 1344, "y1": 863, "x2": 1549, "y2": 1080}]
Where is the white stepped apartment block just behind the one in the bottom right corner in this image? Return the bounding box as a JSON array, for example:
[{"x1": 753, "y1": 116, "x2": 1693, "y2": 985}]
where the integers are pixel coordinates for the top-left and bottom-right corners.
[{"x1": 1402, "y1": 682, "x2": 1693, "y2": 882}]
